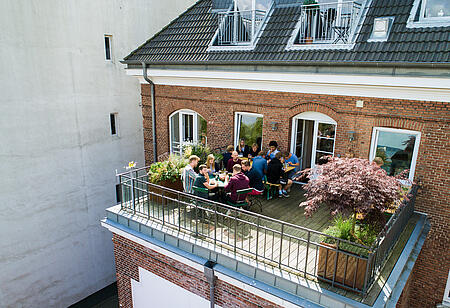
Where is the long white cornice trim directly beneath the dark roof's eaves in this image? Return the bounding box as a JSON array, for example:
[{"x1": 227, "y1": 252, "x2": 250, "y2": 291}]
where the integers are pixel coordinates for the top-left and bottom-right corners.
[{"x1": 127, "y1": 69, "x2": 450, "y2": 102}]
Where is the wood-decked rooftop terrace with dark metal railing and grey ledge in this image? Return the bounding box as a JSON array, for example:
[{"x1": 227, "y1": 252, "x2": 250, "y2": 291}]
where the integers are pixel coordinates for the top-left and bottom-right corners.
[{"x1": 105, "y1": 168, "x2": 426, "y2": 306}]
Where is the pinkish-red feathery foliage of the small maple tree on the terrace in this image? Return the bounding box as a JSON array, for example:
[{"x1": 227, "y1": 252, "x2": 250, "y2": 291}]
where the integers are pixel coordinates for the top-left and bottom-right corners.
[{"x1": 300, "y1": 157, "x2": 401, "y2": 232}]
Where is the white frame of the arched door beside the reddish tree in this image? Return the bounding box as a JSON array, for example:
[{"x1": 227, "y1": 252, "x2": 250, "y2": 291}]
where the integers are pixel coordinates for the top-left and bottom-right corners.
[{"x1": 291, "y1": 111, "x2": 338, "y2": 168}]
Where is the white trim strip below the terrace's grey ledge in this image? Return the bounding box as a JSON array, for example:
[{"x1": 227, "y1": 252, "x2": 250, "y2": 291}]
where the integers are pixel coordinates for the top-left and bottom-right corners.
[{"x1": 100, "y1": 221, "x2": 299, "y2": 308}]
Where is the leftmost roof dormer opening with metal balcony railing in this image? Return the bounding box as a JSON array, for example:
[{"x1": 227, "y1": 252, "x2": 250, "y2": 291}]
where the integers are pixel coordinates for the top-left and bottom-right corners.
[{"x1": 217, "y1": 10, "x2": 266, "y2": 46}]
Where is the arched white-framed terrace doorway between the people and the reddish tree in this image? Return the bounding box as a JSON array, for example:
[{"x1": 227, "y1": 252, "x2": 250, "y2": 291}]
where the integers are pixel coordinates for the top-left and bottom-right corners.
[{"x1": 291, "y1": 111, "x2": 337, "y2": 170}]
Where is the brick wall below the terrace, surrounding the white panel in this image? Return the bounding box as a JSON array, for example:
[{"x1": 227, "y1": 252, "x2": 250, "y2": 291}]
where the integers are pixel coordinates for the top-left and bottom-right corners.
[{"x1": 113, "y1": 234, "x2": 281, "y2": 308}]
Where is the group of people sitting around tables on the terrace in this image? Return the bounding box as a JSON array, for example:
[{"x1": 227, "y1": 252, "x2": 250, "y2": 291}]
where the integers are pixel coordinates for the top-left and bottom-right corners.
[{"x1": 182, "y1": 139, "x2": 300, "y2": 202}]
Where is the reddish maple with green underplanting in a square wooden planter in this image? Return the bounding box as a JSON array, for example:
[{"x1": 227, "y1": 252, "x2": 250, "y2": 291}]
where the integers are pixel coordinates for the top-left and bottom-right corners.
[{"x1": 300, "y1": 158, "x2": 402, "y2": 290}]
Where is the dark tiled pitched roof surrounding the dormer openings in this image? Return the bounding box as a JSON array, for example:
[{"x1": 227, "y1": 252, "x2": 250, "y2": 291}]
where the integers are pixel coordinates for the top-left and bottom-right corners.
[{"x1": 125, "y1": 0, "x2": 450, "y2": 64}]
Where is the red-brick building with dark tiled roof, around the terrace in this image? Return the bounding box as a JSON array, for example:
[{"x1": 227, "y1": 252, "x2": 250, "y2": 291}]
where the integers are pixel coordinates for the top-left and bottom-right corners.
[{"x1": 103, "y1": 0, "x2": 450, "y2": 307}]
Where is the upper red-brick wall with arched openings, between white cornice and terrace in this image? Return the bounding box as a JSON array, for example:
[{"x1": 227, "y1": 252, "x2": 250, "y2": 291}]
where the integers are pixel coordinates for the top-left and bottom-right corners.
[{"x1": 142, "y1": 85, "x2": 450, "y2": 307}]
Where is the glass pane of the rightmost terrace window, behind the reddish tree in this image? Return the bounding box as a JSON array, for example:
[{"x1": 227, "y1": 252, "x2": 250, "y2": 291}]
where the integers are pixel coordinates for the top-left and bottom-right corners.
[{"x1": 375, "y1": 131, "x2": 416, "y2": 176}]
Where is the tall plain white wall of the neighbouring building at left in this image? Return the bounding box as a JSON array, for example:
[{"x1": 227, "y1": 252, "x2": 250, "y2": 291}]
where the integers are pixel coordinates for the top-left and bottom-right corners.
[{"x1": 0, "y1": 0, "x2": 194, "y2": 307}]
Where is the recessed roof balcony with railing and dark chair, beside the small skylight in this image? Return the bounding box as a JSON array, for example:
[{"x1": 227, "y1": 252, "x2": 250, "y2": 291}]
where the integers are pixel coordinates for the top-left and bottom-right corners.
[{"x1": 296, "y1": 1, "x2": 361, "y2": 44}]
